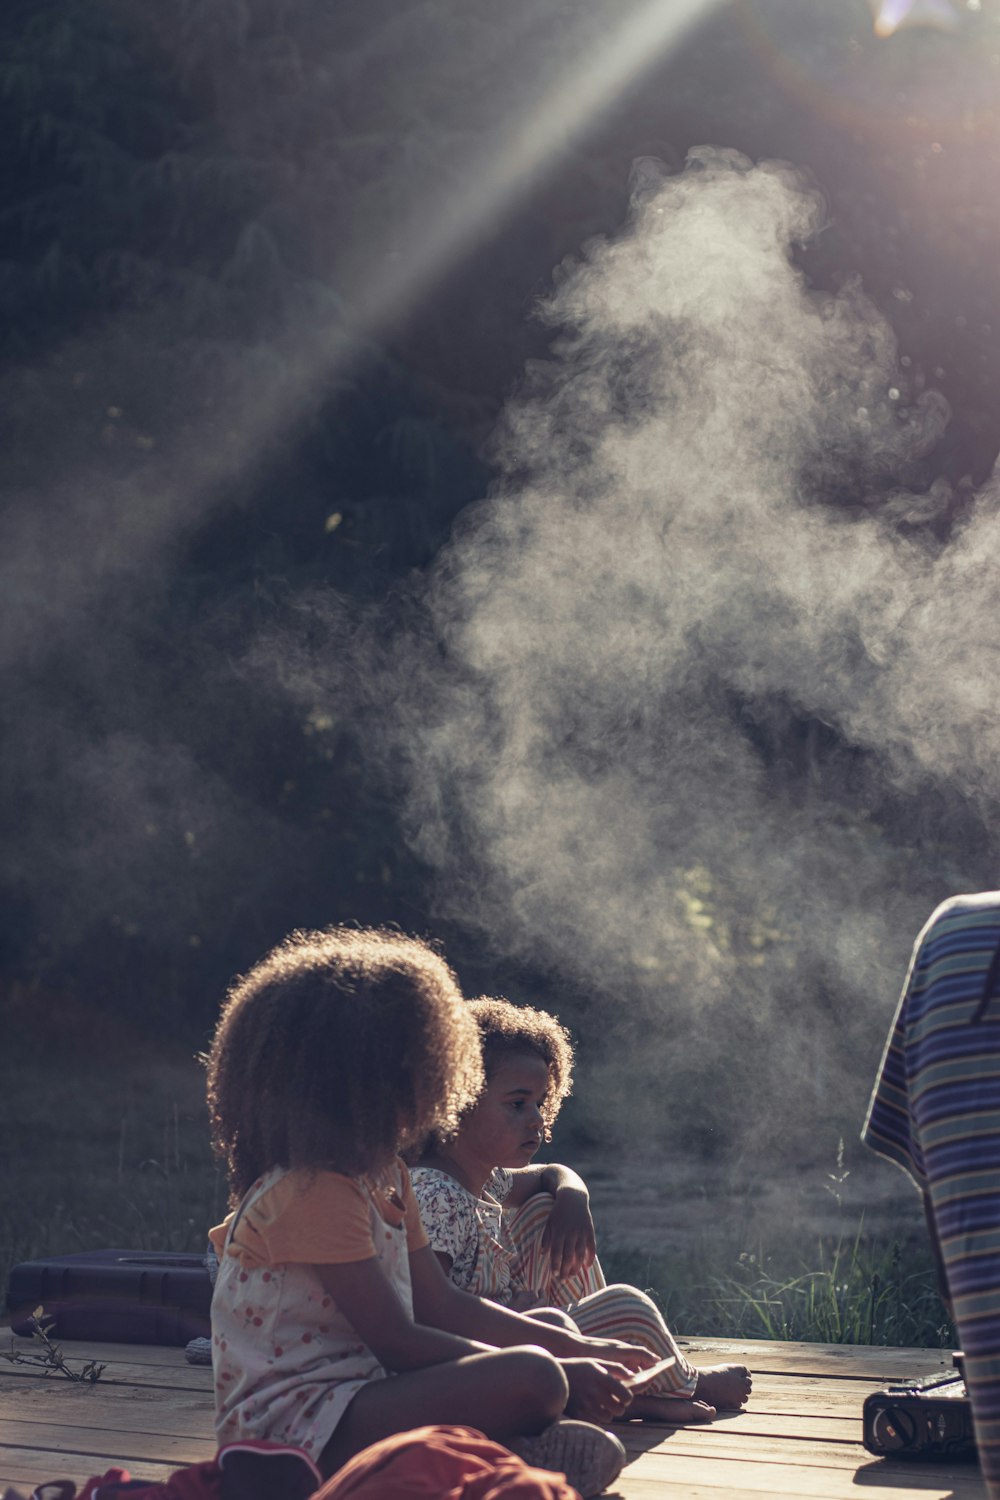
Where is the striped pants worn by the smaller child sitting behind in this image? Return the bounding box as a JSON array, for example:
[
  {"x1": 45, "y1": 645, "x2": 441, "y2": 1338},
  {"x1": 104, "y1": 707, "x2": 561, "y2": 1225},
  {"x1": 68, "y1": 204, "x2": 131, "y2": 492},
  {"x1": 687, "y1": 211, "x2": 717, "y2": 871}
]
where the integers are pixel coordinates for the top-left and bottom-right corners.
[{"x1": 504, "y1": 1193, "x2": 699, "y2": 1397}]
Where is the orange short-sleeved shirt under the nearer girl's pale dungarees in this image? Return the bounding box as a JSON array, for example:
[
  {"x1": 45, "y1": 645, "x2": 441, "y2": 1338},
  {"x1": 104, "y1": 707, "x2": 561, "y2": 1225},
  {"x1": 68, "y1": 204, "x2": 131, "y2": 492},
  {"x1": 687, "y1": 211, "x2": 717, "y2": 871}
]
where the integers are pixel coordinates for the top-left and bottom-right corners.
[{"x1": 208, "y1": 1161, "x2": 427, "y2": 1266}]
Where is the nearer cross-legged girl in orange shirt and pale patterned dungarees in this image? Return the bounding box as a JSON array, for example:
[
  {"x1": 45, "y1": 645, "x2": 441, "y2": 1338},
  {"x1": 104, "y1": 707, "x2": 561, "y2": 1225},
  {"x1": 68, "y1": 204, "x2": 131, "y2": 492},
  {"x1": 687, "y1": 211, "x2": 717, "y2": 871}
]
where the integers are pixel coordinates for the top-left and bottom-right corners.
[{"x1": 207, "y1": 929, "x2": 651, "y2": 1496}]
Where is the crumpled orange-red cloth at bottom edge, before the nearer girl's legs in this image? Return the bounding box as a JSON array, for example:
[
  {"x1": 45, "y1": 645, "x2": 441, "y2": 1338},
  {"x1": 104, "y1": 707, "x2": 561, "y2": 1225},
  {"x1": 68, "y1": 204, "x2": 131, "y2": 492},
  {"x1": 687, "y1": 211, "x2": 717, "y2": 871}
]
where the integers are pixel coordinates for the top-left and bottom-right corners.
[{"x1": 312, "y1": 1427, "x2": 580, "y2": 1500}]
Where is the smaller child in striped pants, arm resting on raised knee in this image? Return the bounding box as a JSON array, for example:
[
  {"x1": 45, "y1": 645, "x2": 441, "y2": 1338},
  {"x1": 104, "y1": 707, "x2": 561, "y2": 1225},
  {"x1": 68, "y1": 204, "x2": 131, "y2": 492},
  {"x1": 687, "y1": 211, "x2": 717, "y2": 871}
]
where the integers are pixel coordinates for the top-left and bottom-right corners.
[{"x1": 412, "y1": 999, "x2": 751, "y2": 1424}]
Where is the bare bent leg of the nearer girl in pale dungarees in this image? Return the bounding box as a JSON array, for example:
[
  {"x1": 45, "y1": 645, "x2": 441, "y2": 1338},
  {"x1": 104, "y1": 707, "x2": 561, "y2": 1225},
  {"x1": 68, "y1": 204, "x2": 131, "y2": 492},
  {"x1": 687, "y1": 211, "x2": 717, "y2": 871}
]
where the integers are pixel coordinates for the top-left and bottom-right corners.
[{"x1": 319, "y1": 1347, "x2": 570, "y2": 1478}]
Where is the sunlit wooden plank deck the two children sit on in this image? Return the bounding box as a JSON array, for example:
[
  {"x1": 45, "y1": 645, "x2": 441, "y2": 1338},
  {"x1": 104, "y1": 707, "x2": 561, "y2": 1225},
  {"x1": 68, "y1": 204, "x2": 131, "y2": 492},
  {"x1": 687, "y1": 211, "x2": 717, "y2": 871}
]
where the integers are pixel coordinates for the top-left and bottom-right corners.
[{"x1": 0, "y1": 1332, "x2": 985, "y2": 1500}]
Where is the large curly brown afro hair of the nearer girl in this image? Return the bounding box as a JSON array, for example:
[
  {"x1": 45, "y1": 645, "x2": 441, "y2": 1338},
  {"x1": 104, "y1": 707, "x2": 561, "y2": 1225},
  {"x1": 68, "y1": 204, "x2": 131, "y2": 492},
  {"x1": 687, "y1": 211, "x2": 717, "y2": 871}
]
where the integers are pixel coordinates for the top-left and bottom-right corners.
[{"x1": 205, "y1": 927, "x2": 483, "y2": 1206}]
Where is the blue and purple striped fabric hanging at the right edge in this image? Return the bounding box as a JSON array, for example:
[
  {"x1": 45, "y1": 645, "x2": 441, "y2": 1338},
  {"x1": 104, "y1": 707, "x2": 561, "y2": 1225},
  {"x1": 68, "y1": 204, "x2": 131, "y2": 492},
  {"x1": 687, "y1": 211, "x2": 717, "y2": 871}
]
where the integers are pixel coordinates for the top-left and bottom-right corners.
[{"x1": 862, "y1": 891, "x2": 1000, "y2": 1500}]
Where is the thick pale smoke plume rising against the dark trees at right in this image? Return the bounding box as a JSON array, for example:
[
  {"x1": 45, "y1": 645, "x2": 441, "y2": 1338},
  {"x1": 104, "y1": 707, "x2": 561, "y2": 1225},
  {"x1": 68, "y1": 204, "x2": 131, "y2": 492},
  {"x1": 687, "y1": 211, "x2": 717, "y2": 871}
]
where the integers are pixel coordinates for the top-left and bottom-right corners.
[{"x1": 364, "y1": 149, "x2": 1000, "y2": 1152}]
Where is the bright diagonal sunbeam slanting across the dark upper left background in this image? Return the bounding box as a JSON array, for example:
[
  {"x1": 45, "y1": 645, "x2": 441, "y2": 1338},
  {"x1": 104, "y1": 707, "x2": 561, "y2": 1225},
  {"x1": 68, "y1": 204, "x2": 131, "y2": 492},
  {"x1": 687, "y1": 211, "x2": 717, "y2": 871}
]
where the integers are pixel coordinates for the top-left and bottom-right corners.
[{"x1": 4, "y1": 0, "x2": 718, "y2": 651}]
